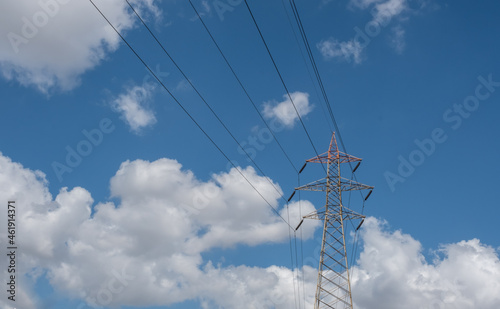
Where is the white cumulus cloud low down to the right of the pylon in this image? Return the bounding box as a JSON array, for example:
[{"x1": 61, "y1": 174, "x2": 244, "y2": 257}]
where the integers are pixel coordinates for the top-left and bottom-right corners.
[{"x1": 352, "y1": 218, "x2": 500, "y2": 309}]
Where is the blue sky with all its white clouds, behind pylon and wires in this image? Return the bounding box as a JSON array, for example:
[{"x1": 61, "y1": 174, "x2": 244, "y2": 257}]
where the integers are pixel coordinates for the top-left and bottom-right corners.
[{"x1": 0, "y1": 0, "x2": 500, "y2": 309}]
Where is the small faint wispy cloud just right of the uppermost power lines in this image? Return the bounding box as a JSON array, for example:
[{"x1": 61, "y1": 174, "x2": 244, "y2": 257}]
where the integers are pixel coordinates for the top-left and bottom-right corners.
[{"x1": 317, "y1": 38, "x2": 363, "y2": 63}]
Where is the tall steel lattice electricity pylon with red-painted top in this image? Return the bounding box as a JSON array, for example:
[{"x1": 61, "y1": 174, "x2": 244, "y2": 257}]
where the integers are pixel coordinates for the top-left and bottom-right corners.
[{"x1": 295, "y1": 133, "x2": 373, "y2": 309}]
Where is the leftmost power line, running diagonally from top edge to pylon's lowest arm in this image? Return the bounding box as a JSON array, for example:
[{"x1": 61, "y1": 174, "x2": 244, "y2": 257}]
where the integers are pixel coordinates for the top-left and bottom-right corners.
[{"x1": 89, "y1": 0, "x2": 294, "y2": 229}]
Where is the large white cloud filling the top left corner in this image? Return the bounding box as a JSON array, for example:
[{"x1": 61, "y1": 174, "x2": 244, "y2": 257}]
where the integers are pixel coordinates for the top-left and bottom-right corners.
[{"x1": 0, "y1": 0, "x2": 160, "y2": 93}]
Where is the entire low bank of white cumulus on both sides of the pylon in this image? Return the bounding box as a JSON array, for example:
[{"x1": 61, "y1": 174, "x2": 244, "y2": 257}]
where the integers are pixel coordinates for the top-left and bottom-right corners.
[{"x1": 0, "y1": 155, "x2": 500, "y2": 309}]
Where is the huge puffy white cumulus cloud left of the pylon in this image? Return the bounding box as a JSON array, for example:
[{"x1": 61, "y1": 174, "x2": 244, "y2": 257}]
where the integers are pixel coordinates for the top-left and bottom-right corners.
[{"x1": 0, "y1": 155, "x2": 319, "y2": 309}]
